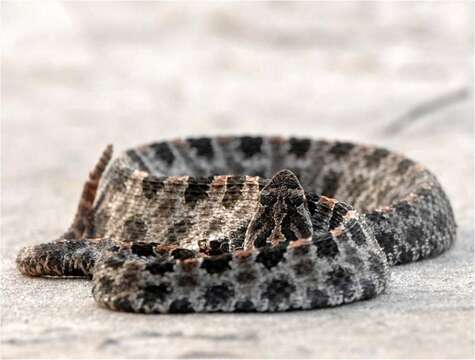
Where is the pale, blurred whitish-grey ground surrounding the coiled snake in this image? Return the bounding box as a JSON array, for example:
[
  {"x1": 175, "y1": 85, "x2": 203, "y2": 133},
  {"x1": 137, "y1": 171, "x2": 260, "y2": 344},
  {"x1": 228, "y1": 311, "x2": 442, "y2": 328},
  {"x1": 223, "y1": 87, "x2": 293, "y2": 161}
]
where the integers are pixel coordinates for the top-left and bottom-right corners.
[{"x1": 1, "y1": 2, "x2": 474, "y2": 358}]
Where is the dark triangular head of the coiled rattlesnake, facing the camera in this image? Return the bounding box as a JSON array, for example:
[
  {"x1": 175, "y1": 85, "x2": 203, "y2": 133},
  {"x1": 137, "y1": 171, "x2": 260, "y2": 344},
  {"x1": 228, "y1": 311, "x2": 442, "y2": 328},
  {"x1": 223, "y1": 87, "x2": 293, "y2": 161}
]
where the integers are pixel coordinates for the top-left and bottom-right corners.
[{"x1": 244, "y1": 170, "x2": 313, "y2": 249}]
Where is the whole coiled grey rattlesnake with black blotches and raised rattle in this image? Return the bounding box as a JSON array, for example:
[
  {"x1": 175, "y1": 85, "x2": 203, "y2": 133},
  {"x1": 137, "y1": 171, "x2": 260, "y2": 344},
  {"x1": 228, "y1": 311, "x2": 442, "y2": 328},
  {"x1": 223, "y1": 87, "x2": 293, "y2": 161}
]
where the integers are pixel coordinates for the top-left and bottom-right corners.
[{"x1": 17, "y1": 136, "x2": 456, "y2": 313}]
